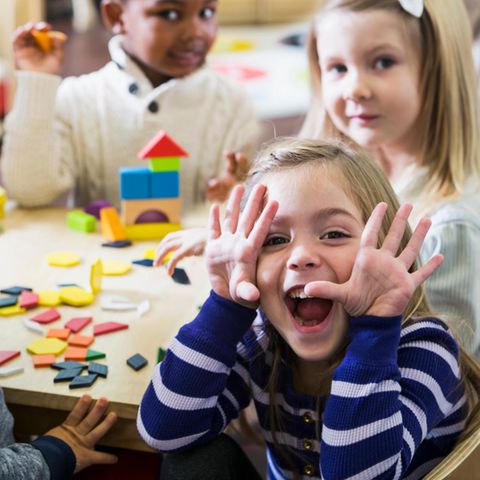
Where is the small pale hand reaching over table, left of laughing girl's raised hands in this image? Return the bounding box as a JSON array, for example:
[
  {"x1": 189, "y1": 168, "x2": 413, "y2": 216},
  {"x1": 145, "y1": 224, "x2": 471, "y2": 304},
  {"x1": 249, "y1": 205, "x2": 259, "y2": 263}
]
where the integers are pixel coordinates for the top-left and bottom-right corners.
[{"x1": 154, "y1": 227, "x2": 208, "y2": 275}]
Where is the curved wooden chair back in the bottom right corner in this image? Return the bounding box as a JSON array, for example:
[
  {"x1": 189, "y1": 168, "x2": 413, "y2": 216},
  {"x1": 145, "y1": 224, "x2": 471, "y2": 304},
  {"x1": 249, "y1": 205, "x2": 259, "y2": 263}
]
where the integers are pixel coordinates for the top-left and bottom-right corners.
[{"x1": 424, "y1": 358, "x2": 480, "y2": 480}]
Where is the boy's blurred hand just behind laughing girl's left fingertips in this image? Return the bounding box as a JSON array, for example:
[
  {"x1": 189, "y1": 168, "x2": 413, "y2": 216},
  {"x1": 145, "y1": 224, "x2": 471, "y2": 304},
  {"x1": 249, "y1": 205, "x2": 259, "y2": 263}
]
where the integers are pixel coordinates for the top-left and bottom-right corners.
[{"x1": 206, "y1": 152, "x2": 248, "y2": 202}]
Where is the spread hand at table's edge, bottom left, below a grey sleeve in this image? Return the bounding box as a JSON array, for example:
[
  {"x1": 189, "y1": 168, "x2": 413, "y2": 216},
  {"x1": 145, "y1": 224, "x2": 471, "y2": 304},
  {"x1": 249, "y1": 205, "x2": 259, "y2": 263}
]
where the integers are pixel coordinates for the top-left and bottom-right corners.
[{"x1": 46, "y1": 395, "x2": 117, "y2": 473}]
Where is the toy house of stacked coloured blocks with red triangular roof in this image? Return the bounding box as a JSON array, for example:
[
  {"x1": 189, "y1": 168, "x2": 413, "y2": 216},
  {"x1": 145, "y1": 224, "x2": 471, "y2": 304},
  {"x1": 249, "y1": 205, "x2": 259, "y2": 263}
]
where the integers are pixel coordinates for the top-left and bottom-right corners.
[{"x1": 120, "y1": 130, "x2": 188, "y2": 240}]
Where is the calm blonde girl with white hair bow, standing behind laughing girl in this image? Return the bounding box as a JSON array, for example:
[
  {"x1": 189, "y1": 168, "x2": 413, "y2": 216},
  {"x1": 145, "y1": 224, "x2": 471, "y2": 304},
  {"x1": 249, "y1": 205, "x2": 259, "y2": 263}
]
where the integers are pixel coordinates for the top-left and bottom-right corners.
[{"x1": 301, "y1": 0, "x2": 480, "y2": 357}]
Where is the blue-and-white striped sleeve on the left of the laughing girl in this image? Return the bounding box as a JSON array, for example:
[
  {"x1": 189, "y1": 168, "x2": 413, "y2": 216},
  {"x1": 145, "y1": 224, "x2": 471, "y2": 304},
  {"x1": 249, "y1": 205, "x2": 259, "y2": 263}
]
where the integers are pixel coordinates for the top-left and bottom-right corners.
[{"x1": 137, "y1": 292, "x2": 256, "y2": 452}]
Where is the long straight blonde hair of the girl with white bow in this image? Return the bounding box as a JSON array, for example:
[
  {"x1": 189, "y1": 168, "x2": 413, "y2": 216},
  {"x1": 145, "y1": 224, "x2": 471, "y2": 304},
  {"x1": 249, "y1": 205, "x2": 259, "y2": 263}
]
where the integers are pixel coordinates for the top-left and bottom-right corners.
[{"x1": 300, "y1": 0, "x2": 480, "y2": 203}]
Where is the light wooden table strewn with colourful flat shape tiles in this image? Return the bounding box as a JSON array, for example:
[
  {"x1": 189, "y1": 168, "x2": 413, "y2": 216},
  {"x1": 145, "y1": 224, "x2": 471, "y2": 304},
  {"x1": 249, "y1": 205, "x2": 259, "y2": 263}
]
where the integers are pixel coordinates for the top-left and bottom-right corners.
[{"x1": 0, "y1": 209, "x2": 209, "y2": 451}]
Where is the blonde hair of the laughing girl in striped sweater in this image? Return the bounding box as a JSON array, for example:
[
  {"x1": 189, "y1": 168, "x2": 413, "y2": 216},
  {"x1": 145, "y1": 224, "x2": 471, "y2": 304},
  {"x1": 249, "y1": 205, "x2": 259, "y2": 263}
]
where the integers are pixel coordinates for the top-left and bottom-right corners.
[{"x1": 245, "y1": 139, "x2": 480, "y2": 476}]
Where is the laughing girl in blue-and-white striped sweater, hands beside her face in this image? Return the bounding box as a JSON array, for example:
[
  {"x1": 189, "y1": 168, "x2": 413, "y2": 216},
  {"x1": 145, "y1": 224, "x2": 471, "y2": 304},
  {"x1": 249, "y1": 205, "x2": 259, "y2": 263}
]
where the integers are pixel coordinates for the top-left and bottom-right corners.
[{"x1": 138, "y1": 140, "x2": 473, "y2": 480}]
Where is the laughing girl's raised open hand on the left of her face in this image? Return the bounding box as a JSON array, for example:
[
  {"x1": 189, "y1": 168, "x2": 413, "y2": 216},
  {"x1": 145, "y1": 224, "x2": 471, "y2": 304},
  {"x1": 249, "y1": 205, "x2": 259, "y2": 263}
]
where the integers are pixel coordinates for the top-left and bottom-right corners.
[{"x1": 205, "y1": 185, "x2": 278, "y2": 308}]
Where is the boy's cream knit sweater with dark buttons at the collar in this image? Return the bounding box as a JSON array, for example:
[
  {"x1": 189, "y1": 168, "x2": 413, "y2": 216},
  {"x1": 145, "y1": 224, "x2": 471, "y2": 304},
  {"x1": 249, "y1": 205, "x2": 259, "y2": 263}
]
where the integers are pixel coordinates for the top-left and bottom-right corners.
[{"x1": 1, "y1": 37, "x2": 258, "y2": 211}]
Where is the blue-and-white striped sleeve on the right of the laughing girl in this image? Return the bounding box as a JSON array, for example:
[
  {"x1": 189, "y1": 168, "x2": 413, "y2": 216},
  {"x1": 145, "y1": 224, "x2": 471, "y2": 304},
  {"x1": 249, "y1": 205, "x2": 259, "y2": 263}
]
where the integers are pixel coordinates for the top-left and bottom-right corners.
[{"x1": 320, "y1": 316, "x2": 465, "y2": 480}]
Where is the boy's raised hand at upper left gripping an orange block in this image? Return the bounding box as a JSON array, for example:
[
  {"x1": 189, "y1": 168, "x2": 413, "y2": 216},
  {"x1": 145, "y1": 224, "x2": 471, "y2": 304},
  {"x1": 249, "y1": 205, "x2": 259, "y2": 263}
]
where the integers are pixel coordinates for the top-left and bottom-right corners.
[{"x1": 13, "y1": 22, "x2": 67, "y2": 75}]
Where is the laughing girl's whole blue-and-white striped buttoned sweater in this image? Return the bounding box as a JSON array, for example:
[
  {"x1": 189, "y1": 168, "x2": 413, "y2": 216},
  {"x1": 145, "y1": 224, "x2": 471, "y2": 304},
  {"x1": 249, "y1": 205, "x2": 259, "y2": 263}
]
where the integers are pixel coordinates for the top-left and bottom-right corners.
[{"x1": 137, "y1": 292, "x2": 467, "y2": 480}]
